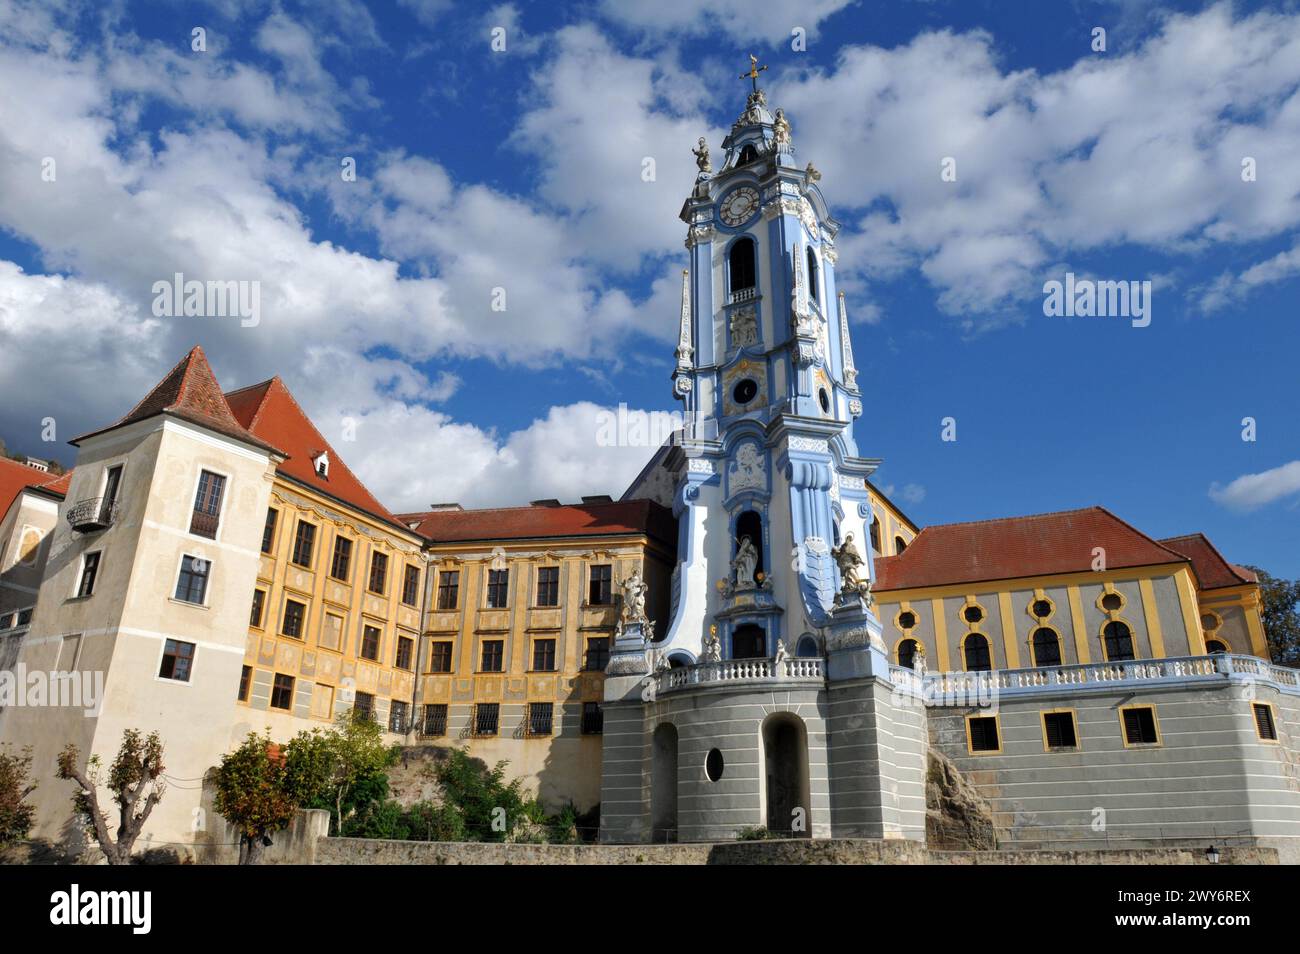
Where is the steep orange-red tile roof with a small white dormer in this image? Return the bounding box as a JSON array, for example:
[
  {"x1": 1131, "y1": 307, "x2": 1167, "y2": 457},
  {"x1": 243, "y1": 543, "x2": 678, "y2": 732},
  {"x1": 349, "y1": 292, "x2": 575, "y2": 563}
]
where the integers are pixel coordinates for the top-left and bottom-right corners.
[{"x1": 225, "y1": 376, "x2": 406, "y2": 528}]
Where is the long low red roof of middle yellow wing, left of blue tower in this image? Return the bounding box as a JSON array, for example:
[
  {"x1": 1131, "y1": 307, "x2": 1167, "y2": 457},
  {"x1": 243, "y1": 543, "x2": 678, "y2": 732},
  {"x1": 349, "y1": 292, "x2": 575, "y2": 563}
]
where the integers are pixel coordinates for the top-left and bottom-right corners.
[{"x1": 399, "y1": 500, "x2": 677, "y2": 546}]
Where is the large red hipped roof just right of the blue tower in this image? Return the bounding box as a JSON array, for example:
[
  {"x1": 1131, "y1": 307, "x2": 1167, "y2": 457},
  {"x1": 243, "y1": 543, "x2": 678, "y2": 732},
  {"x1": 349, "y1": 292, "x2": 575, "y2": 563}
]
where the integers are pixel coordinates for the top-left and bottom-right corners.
[{"x1": 872, "y1": 507, "x2": 1187, "y2": 591}]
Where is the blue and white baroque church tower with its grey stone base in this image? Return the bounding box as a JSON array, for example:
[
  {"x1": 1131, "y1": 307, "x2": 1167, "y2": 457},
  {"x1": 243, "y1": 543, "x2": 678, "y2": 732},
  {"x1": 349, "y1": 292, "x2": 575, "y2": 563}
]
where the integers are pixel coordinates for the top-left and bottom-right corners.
[{"x1": 602, "y1": 64, "x2": 924, "y2": 841}]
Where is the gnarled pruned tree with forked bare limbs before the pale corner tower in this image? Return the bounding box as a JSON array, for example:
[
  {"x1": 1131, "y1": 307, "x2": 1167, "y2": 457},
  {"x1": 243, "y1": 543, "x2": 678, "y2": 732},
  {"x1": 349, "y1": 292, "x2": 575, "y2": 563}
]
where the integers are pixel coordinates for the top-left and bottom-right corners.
[{"x1": 57, "y1": 729, "x2": 166, "y2": 864}]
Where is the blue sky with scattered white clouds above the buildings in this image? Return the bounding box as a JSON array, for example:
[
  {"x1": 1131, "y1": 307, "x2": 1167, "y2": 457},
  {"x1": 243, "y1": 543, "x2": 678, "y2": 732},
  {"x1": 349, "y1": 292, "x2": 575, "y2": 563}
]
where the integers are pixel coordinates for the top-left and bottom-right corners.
[{"x1": 0, "y1": 0, "x2": 1300, "y2": 577}]
